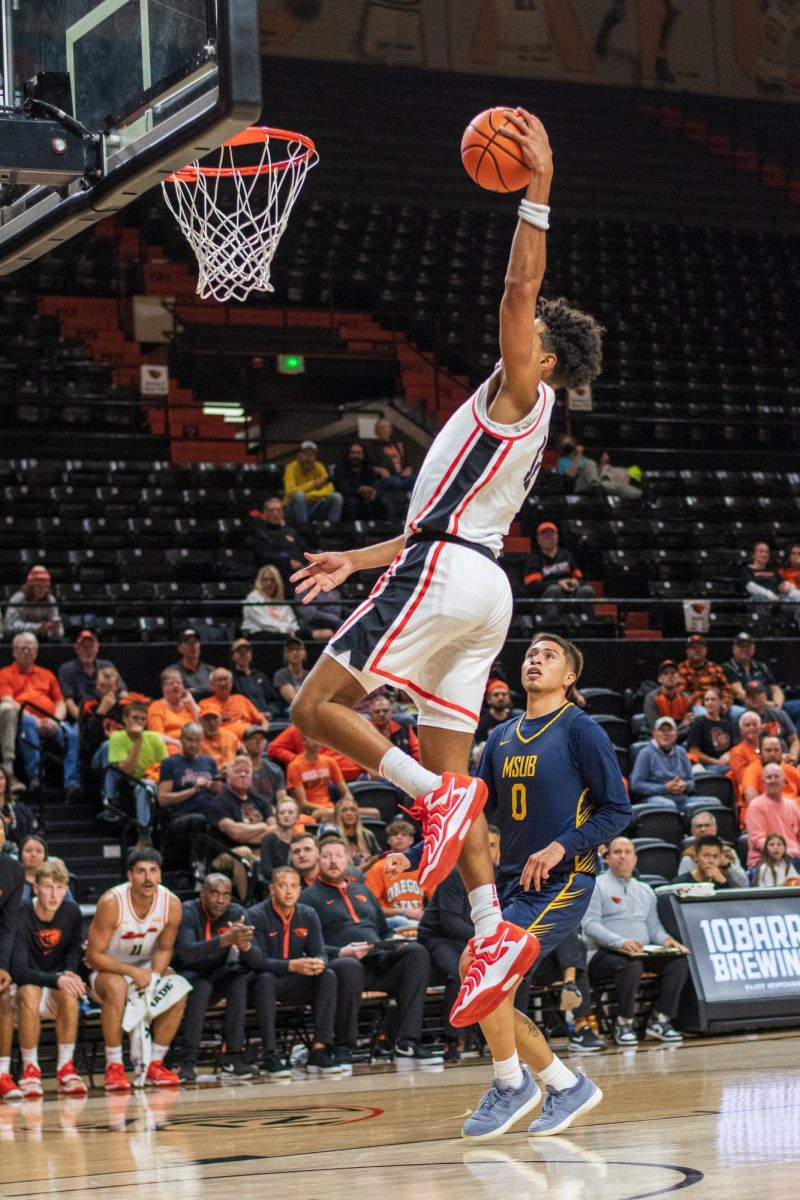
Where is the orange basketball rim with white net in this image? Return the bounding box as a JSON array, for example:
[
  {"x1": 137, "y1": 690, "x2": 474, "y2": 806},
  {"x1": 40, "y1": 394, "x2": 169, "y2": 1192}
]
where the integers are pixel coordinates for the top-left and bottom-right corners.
[{"x1": 162, "y1": 126, "x2": 319, "y2": 300}]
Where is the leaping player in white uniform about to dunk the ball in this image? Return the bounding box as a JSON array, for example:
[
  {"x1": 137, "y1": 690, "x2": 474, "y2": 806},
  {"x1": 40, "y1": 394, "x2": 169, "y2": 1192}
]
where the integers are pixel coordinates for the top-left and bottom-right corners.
[{"x1": 291, "y1": 108, "x2": 601, "y2": 1051}]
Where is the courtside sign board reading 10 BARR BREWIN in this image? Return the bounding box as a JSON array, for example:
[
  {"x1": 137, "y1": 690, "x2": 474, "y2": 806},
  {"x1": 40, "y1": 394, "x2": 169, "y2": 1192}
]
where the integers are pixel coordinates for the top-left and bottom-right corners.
[{"x1": 658, "y1": 888, "x2": 800, "y2": 1032}]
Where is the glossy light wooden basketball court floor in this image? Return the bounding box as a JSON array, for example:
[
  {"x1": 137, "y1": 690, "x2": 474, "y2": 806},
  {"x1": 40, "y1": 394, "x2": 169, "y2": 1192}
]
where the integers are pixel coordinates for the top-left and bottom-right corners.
[{"x1": 0, "y1": 1031, "x2": 800, "y2": 1200}]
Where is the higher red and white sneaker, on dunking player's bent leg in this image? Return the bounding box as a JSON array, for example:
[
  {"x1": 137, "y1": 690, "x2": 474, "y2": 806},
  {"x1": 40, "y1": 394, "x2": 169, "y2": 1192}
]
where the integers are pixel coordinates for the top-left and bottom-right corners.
[{"x1": 408, "y1": 772, "x2": 489, "y2": 890}]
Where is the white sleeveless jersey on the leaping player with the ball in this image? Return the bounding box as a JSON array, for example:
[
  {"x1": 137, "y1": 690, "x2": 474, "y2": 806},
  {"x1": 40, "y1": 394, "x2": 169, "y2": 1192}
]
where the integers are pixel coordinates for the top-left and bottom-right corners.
[{"x1": 405, "y1": 376, "x2": 555, "y2": 556}]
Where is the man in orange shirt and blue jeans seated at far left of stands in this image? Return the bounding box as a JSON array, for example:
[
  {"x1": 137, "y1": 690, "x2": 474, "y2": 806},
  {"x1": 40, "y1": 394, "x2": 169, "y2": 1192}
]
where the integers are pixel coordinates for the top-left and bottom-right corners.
[{"x1": 0, "y1": 634, "x2": 82, "y2": 800}]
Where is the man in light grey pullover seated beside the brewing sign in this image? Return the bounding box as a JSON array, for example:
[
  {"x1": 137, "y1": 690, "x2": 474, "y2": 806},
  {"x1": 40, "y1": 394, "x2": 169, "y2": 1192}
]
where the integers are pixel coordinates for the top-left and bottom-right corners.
[{"x1": 582, "y1": 840, "x2": 688, "y2": 1049}]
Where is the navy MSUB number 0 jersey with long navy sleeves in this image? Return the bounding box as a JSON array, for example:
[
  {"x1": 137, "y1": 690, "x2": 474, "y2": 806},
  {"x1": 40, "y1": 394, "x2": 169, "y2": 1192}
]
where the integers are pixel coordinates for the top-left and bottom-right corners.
[{"x1": 477, "y1": 701, "x2": 631, "y2": 895}]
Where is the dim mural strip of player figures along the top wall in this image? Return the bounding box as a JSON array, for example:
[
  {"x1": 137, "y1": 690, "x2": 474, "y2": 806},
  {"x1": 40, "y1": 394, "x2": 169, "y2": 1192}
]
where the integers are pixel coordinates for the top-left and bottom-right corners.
[{"x1": 260, "y1": 0, "x2": 800, "y2": 101}]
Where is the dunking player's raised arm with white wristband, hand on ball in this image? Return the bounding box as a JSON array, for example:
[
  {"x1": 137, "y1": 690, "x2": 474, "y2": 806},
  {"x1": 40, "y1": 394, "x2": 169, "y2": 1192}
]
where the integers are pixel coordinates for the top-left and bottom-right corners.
[{"x1": 492, "y1": 108, "x2": 555, "y2": 425}]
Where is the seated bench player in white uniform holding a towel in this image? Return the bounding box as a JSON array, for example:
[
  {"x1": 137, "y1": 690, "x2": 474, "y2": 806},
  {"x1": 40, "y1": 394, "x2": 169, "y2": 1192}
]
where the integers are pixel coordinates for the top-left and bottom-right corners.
[{"x1": 86, "y1": 846, "x2": 186, "y2": 1092}]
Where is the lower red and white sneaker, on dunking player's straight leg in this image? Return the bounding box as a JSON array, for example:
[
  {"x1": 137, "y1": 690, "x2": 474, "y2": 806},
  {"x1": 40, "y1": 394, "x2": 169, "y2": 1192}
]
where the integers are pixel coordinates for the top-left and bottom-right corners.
[{"x1": 450, "y1": 920, "x2": 540, "y2": 1027}]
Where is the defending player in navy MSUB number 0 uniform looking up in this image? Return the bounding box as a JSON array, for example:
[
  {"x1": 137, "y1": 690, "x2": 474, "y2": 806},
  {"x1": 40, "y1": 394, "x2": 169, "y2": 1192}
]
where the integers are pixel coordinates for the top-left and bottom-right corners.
[{"x1": 385, "y1": 634, "x2": 631, "y2": 1141}]
